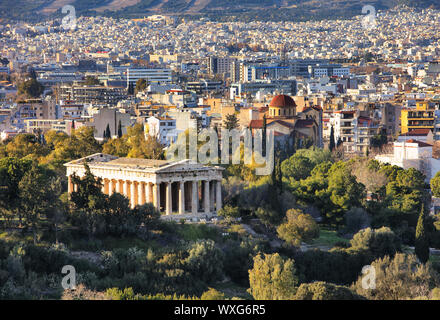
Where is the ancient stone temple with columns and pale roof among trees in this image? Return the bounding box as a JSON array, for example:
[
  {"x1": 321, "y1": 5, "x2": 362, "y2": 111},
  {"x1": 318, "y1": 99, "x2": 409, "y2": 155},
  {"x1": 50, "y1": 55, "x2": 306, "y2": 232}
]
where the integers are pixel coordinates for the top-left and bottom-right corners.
[{"x1": 65, "y1": 153, "x2": 223, "y2": 215}]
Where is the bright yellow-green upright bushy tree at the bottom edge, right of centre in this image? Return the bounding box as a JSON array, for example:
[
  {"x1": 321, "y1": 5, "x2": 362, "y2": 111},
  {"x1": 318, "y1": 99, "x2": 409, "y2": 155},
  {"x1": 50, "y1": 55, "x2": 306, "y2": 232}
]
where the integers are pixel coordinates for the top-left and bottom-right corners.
[{"x1": 249, "y1": 253, "x2": 298, "y2": 300}]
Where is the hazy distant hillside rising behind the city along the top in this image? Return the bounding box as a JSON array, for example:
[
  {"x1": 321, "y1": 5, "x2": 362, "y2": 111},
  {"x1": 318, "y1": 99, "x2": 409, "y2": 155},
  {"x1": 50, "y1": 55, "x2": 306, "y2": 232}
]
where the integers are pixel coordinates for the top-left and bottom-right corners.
[{"x1": 0, "y1": 0, "x2": 440, "y2": 21}]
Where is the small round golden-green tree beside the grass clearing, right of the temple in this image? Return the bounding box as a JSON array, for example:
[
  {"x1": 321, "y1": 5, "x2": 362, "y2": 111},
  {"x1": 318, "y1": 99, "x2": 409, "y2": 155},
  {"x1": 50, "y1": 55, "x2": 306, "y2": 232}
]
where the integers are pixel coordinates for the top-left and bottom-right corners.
[{"x1": 277, "y1": 209, "x2": 319, "y2": 246}]
